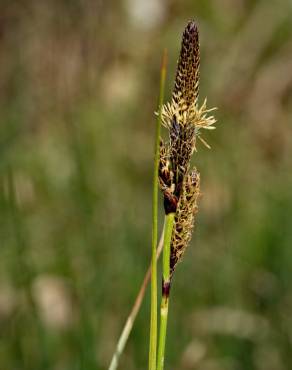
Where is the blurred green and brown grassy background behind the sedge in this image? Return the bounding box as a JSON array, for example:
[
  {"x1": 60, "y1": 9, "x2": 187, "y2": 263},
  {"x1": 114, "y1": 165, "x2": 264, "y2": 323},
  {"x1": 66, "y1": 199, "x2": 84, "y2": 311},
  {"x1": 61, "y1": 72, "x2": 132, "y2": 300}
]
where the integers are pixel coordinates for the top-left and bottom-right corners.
[{"x1": 0, "y1": 0, "x2": 292, "y2": 370}]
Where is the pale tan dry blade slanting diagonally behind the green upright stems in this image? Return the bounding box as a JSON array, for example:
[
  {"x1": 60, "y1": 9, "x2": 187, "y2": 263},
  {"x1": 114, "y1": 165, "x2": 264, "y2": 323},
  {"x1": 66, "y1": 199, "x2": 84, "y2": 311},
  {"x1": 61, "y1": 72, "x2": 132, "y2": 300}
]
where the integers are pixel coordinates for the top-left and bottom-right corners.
[{"x1": 108, "y1": 228, "x2": 164, "y2": 370}]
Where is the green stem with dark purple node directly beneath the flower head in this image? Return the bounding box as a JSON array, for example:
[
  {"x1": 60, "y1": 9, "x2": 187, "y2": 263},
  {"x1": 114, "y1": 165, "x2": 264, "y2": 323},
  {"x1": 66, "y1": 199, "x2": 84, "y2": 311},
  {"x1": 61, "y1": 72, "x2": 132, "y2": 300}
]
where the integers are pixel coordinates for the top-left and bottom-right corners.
[{"x1": 157, "y1": 213, "x2": 175, "y2": 370}]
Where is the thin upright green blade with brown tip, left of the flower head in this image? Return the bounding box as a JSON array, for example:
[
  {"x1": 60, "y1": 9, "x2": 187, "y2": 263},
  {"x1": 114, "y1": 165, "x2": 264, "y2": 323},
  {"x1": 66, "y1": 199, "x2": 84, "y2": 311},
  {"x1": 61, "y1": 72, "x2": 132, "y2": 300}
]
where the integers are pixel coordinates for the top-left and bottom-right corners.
[{"x1": 149, "y1": 50, "x2": 167, "y2": 370}]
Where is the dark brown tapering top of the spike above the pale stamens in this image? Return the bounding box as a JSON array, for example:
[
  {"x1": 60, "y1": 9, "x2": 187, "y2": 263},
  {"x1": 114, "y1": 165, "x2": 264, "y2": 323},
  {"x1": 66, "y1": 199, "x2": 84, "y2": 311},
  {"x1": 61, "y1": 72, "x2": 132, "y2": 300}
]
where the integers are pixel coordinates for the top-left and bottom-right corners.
[{"x1": 172, "y1": 21, "x2": 200, "y2": 107}]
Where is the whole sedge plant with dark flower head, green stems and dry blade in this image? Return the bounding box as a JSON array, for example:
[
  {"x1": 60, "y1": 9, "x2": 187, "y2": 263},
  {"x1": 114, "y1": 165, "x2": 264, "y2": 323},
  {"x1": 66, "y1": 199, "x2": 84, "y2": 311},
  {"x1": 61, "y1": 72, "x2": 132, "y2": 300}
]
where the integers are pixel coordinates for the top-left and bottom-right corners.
[{"x1": 109, "y1": 21, "x2": 216, "y2": 370}]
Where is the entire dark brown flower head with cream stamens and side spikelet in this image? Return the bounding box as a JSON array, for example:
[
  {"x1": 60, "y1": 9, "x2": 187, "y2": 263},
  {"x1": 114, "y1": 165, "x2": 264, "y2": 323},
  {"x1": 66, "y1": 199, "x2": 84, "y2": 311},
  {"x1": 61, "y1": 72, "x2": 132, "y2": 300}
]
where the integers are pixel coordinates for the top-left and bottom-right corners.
[{"x1": 159, "y1": 21, "x2": 216, "y2": 275}]
